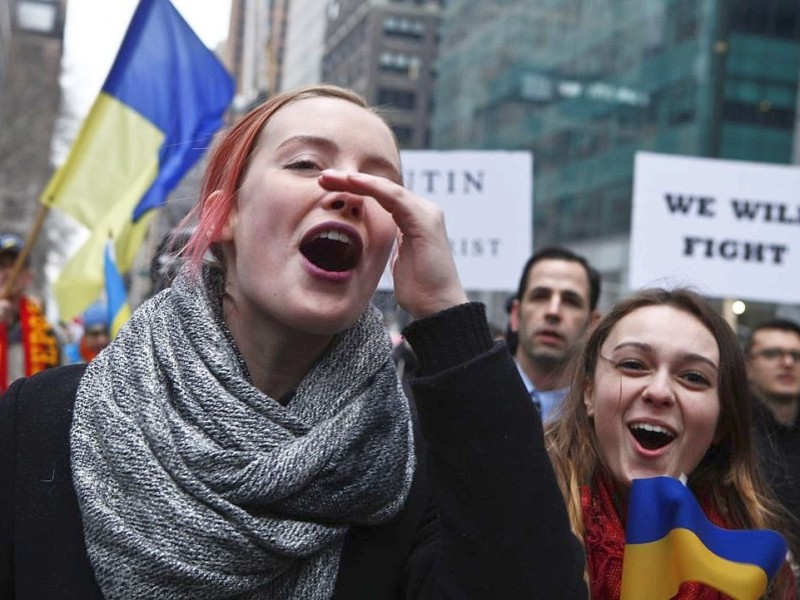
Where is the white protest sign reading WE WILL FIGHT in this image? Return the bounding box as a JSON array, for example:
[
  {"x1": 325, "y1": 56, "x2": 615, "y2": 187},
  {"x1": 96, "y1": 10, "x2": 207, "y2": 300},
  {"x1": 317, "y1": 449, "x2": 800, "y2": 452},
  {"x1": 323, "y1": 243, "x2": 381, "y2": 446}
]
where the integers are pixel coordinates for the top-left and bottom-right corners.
[{"x1": 629, "y1": 152, "x2": 800, "y2": 304}]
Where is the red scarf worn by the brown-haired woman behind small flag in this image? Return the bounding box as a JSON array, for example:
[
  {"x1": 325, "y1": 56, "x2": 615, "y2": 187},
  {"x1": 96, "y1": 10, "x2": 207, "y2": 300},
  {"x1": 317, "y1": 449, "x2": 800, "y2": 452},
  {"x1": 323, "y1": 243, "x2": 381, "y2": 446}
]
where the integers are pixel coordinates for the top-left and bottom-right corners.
[{"x1": 581, "y1": 476, "x2": 729, "y2": 600}]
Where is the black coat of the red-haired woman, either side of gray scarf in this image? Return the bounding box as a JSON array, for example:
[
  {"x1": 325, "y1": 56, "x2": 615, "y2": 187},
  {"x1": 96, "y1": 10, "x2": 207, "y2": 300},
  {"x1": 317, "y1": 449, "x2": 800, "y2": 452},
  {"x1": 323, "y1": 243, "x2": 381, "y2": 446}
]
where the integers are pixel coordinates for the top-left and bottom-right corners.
[{"x1": 0, "y1": 344, "x2": 587, "y2": 600}]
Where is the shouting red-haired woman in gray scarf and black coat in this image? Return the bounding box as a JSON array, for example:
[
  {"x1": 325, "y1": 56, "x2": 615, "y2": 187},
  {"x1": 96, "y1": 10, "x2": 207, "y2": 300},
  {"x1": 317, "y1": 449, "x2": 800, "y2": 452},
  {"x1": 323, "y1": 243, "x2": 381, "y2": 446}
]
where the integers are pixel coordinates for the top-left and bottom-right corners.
[{"x1": 0, "y1": 85, "x2": 586, "y2": 600}]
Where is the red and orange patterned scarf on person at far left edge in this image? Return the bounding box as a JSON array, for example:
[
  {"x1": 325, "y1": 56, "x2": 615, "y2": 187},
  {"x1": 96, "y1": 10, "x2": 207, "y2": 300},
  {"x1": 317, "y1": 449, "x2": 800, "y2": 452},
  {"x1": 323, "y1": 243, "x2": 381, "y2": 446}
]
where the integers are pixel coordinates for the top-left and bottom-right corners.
[{"x1": 0, "y1": 297, "x2": 61, "y2": 392}]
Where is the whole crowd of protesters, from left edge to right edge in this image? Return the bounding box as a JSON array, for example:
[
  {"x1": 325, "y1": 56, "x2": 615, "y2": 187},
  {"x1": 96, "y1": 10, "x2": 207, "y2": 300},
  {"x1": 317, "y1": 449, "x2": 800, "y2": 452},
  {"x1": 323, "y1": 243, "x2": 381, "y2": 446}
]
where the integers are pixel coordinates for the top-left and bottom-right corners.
[{"x1": 0, "y1": 85, "x2": 800, "y2": 600}]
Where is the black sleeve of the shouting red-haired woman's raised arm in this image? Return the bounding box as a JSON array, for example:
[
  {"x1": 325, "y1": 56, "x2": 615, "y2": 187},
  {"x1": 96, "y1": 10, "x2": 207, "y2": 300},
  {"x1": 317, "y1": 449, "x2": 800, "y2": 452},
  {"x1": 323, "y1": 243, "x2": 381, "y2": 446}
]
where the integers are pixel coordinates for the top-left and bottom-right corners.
[{"x1": 405, "y1": 303, "x2": 588, "y2": 599}]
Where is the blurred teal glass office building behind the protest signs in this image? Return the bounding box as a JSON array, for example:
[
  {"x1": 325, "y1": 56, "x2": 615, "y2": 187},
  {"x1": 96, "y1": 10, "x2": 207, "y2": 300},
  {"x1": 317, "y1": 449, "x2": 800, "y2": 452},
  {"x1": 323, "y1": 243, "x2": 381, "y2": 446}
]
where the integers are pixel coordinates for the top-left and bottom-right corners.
[{"x1": 432, "y1": 0, "x2": 800, "y2": 262}]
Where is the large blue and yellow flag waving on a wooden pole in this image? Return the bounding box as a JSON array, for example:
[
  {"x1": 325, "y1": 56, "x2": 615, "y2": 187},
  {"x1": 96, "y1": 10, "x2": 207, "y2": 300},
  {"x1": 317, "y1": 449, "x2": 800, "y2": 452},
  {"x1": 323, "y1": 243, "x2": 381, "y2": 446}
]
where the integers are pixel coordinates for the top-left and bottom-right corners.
[{"x1": 41, "y1": 0, "x2": 234, "y2": 321}]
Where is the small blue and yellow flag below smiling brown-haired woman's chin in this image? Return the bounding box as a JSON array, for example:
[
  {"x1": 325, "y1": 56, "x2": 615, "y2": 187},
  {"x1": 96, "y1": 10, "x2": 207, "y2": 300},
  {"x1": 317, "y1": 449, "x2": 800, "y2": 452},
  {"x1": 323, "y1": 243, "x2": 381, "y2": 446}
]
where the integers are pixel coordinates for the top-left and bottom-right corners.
[{"x1": 620, "y1": 477, "x2": 786, "y2": 600}]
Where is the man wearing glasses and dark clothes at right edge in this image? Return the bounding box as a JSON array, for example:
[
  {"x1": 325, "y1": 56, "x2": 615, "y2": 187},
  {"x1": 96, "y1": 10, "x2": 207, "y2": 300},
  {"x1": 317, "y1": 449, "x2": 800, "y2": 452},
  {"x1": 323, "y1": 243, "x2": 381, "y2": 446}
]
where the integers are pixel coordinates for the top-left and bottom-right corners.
[{"x1": 745, "y1": 319, "x2": 800, "y2": 562}]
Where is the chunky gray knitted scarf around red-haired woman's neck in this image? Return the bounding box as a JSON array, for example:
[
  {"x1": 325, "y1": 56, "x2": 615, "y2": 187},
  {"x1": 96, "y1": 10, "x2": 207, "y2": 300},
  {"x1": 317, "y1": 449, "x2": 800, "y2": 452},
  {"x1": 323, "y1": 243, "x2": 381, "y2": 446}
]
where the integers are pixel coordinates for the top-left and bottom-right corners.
[{"x1": 71, "y1": 270, "x2": 414, "y2": 600}]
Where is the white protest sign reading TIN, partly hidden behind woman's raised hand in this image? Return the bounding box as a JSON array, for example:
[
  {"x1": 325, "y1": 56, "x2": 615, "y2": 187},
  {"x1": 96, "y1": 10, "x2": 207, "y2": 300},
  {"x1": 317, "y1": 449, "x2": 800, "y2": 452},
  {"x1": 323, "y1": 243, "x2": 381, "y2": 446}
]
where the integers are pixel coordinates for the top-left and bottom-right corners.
[{"x1": 380, "y1": 150, "x2": 533, "y2": 291}]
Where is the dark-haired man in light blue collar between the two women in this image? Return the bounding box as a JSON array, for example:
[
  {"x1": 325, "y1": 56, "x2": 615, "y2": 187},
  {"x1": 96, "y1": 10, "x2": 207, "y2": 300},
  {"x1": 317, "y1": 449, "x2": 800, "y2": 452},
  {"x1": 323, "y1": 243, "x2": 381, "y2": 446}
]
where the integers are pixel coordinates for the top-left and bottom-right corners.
[{"x1": 508, "y1": 247, "x2": 600, "y2": 421}]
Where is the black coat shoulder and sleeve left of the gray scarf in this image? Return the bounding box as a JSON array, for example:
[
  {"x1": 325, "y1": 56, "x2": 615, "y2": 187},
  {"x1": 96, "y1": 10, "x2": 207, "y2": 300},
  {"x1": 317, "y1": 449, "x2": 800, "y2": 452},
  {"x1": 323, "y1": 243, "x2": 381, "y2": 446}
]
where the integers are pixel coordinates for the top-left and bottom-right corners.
[{"x1": 0, "y1": 364, "x2": 102, "y2": 600}]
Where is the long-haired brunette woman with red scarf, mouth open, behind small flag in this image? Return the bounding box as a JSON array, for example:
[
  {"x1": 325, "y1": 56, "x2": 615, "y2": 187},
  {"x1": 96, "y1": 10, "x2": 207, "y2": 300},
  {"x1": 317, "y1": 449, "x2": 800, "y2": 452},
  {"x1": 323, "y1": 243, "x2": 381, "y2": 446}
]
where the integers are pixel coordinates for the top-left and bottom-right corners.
[{"x1": 546, "y1": 289, "x2": 796, "y2": 600}]
